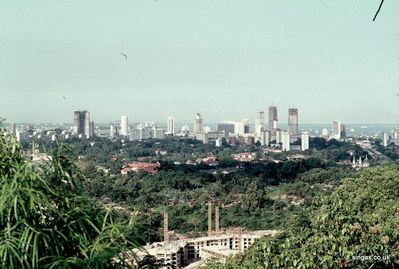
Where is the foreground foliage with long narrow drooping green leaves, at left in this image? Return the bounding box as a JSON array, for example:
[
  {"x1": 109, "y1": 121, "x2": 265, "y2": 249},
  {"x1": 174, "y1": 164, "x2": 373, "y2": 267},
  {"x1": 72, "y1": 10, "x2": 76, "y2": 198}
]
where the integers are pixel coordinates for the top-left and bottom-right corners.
[{"x1": 0, "y1": 127, "x2": 141, "y2": 268}]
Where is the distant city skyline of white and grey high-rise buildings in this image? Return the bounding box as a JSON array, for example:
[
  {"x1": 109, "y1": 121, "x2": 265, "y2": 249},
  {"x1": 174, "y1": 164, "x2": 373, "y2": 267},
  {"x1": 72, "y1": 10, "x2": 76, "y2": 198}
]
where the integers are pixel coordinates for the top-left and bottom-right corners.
[{"x1": 9, "y1": 105, "x2": 399, "y2": 151}]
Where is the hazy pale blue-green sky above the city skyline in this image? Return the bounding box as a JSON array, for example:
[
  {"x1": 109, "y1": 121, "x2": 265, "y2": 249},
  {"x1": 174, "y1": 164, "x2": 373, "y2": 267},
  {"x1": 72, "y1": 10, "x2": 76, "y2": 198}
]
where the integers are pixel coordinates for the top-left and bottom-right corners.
[{"x1": 0, "y1": 0, "x2": 399, "y2": 123}]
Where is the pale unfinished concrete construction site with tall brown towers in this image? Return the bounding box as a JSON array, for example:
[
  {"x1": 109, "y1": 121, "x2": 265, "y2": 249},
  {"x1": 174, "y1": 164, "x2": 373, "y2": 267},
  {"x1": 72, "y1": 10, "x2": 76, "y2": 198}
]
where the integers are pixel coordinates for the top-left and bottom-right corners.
[{"x1": 129, "y1": 201, "x2": 279, "y2": 269}]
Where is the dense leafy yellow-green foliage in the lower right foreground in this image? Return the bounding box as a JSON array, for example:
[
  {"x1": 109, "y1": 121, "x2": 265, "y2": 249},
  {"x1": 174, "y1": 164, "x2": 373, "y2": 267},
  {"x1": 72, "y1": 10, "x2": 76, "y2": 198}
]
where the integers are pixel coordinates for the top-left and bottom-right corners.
[{"x1": 210, "y1": 167, "x2": 399, "y2": 269}]
